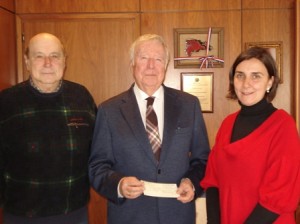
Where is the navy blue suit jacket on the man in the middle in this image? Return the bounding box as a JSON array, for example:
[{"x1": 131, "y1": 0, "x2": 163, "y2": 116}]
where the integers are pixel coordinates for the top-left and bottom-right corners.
[{"x1": 89, "y1": 86, "x2": 210, "y2": 224}]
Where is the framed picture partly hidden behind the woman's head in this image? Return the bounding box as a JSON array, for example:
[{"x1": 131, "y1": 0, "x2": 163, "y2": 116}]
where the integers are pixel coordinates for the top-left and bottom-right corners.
[{"x1": 245, "y1": 41, "x2": 283, "y2": 83}]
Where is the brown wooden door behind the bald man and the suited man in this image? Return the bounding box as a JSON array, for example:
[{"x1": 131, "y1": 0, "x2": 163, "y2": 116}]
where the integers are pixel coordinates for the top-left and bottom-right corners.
[{"x1": 18, "y1": 14, "x2": 139, "y2": 224}]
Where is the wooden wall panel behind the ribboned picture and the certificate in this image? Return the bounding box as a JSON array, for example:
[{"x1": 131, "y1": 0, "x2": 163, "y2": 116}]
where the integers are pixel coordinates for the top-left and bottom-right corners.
[{"x1": 141, "y1": 10, "x2": 241, "y2": 150}]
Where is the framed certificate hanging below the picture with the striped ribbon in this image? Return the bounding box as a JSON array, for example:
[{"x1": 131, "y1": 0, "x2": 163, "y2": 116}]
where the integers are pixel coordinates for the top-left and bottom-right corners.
[{"x1": 181, "y1": 72, "x2": 213, "y2": 113}]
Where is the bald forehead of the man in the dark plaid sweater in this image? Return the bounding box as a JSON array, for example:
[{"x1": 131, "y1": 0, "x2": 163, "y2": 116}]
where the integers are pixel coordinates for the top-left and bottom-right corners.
[{"x1": 28, "y1": 35, "x2": 64, "y2": 54}]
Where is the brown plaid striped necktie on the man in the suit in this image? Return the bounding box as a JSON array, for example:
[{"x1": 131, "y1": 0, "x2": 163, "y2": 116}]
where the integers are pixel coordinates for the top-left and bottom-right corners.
[{"x1": 146, "y1": 97, "x2": 161, "y2": 161}]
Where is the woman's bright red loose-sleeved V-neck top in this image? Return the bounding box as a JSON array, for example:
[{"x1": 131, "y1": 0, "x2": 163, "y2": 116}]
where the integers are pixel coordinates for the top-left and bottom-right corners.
[{"x1": 200, "y1": 110, "x2": 300, "y2": 224}]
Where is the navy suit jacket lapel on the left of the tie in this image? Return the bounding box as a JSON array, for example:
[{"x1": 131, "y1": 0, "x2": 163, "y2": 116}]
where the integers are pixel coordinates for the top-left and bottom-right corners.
[{"x1": 120, "y1": 87, "x2": 157, "y2": 164}]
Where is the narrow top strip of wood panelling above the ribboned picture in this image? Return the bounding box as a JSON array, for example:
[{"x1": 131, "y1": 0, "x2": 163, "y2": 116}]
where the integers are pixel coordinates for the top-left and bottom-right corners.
[{"x1": 141, "y1": 0, "x2": 241, "y2": 12}]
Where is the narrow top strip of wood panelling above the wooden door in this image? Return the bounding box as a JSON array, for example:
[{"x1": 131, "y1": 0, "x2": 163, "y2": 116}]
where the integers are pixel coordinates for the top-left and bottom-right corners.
[{"x1": 15, "y1": 0, "x2": 139, "y2": 14}]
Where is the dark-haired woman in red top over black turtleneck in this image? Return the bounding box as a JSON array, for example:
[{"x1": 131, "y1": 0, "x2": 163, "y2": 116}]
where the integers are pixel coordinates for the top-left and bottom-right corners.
[{"x1": 200, "y1": 47, "x2": 300, "y2": 224}]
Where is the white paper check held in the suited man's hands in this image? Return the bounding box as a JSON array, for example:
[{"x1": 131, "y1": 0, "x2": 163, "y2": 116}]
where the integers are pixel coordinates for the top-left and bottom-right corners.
[{"x1": 143, "y1": 181, "x2": 179, "y2": 198}]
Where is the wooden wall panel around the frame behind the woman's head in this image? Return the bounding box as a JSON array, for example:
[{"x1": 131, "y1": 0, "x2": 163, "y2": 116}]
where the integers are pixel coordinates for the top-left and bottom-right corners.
[{"x1": 242, "y1": 9, "x2": 295, "y2": 115}]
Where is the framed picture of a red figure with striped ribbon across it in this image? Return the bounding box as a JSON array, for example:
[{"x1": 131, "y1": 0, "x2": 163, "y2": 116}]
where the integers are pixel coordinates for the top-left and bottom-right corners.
[{"x1": 174, "y1": 28, "x2": 224, "y2": 68}]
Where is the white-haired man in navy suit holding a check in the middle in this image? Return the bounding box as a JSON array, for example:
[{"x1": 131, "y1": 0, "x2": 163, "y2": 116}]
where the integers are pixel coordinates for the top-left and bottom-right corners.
[{"x1": 89, "y1": 34, "x2": 210, "y2": 224}]
